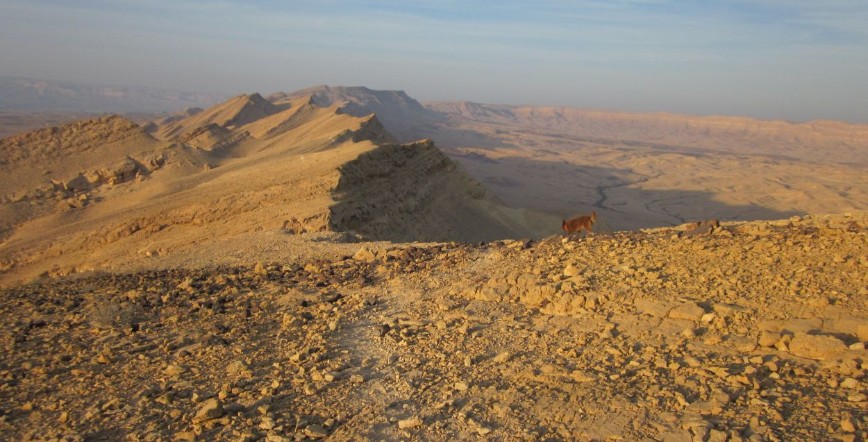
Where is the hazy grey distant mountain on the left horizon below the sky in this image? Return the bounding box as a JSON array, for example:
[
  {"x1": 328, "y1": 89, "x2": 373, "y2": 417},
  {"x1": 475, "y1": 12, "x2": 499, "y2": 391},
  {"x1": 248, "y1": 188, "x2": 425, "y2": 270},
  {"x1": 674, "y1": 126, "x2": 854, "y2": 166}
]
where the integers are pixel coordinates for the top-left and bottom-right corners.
[{"x1": 0, "y1": 77, "x2": 227, "y2": 113}]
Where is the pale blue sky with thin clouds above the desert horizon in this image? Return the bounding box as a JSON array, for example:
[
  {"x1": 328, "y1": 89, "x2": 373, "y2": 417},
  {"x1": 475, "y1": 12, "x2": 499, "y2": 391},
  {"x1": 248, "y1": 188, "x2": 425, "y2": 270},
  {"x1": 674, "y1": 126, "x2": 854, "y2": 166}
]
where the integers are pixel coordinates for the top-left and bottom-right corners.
[{"x1": 0, "y1": 0, "x2": 868, "y2": 123}]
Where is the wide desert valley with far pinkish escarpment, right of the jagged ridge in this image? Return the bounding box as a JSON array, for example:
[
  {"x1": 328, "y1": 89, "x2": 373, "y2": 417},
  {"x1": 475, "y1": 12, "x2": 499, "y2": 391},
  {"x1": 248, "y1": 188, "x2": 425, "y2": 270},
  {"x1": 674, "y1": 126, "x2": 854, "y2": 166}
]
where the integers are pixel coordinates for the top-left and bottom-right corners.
[{"x1": 246, "y1": 86, "x2": 868, "y2": 231}]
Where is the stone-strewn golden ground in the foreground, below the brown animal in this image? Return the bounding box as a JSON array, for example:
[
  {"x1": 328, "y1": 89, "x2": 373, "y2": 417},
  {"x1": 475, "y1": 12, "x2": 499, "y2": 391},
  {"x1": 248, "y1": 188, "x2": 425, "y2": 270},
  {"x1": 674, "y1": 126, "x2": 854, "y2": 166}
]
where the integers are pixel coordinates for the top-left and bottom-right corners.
[{"x1": 0, "y1": 213, "x2": 868, "y2": 441}]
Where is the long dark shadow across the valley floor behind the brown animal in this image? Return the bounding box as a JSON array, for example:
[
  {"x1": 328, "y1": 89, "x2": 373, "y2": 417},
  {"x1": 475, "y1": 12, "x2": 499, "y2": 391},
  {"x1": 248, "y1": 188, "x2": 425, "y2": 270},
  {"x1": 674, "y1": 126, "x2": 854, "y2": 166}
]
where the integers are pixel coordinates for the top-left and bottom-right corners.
[{"x1": 453, "y1": 154, "x2": 805, "y2": 232}]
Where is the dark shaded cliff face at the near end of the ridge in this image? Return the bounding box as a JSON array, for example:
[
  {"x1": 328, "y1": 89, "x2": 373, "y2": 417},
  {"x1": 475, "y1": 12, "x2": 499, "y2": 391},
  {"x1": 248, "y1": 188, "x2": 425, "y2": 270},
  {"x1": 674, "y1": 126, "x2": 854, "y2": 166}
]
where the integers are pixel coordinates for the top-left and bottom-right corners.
[{"x1": 330, "y1": 140, "x2": 557, "y2": 242}]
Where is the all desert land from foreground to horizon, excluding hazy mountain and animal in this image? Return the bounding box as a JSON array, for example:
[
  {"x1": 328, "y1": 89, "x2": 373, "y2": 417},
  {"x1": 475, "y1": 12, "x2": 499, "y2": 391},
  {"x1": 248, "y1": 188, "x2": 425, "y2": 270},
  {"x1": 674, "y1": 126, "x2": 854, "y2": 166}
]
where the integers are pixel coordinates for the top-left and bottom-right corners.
[{"x1": 0, "y1": 86, "x2": 868, "y2": 441}]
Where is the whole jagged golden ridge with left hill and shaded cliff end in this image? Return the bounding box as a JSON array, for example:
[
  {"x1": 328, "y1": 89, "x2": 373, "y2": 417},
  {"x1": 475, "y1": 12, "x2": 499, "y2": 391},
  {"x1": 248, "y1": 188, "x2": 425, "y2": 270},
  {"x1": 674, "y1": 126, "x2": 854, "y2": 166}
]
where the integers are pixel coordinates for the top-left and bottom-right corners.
[{"x1": 0, "y1": 94, "x2": 557, "y2": 282}]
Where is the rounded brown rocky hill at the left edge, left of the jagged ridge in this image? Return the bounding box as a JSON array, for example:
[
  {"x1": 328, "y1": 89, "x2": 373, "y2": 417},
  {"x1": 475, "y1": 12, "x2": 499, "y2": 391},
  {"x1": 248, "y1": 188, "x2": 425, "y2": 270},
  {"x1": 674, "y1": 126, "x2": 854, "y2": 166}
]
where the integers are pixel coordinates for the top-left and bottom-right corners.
[{"x1": 0, "y1": 116, "x2": 166, "y2": 239}]
